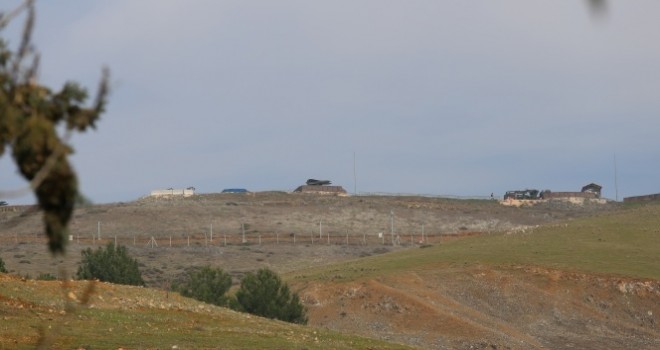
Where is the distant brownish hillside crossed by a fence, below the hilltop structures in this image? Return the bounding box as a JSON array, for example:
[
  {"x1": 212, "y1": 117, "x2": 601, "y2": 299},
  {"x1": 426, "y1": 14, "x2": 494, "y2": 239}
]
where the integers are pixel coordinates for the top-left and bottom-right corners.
[{"x1": 0, "y1": 192, "x2": 618, "y2": 287}]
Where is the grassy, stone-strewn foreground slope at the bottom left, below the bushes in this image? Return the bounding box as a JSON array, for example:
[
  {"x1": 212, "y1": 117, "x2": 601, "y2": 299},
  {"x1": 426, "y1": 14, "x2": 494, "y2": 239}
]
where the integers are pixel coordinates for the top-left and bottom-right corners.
[{"x1": 0, "y1": 274, "x2": 411, "y2": 349}]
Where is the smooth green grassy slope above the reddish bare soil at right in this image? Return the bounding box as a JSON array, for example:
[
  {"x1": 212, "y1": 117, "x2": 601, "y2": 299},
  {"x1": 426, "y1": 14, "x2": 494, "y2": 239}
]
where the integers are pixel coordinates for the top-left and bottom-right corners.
[{"x1": 288, "y1": 204, "x2": 660, "y2": 280}]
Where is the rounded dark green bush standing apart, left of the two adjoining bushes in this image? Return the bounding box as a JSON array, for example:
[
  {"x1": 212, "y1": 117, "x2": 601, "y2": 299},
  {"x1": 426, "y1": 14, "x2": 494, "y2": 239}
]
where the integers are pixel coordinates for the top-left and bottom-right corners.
[{"x1": 76, "y1": 242, "x2": 144, "y2": 286}]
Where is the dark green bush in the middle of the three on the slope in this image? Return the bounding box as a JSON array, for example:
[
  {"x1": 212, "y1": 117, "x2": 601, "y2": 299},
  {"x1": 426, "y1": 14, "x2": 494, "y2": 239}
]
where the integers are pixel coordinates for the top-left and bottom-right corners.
[{"x1": 173, "y1": 266, "x2": 231, "y2": 306}]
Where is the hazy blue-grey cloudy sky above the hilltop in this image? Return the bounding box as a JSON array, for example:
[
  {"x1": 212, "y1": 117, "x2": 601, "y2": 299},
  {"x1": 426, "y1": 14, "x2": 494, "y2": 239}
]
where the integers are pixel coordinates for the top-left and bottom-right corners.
[{"x1": 0, "y1": 0, "x2": 660, "y2": 204}]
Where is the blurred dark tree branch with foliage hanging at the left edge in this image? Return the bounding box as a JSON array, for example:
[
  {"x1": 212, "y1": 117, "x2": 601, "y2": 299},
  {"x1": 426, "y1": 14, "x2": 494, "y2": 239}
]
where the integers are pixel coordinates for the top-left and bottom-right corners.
[{"x1": 0, "y1": 1, "x2": 108, "y2": 254}]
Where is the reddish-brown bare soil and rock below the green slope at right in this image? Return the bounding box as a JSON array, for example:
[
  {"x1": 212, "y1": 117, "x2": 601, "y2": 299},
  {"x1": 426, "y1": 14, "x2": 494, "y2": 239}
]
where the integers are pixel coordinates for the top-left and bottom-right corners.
[{"x1": 296, "y1": 267, "x2": 660, "y2": 350}]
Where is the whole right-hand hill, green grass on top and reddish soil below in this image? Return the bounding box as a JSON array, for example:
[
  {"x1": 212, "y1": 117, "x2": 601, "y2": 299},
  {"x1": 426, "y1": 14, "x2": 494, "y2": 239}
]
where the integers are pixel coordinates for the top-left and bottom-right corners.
[{"x1": 289, "y1": 201, "x2": 660, "y2": 349}]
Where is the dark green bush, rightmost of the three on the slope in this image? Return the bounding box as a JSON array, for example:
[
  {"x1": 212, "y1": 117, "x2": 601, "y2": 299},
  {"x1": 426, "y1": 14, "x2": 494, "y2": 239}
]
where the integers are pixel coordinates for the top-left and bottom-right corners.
[{"x1": 236, "y1": 269, "x2": 307, "y2": 324}]
